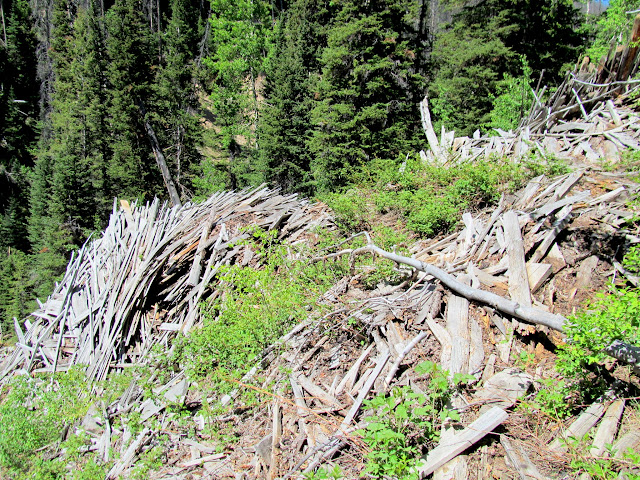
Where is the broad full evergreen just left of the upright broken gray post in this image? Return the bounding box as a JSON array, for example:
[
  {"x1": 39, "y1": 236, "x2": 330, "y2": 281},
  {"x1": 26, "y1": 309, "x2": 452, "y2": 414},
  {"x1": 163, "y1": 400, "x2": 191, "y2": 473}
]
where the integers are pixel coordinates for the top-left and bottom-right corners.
[{"x1": 310, "y1": 0, "x2": 424, "y2": 190}]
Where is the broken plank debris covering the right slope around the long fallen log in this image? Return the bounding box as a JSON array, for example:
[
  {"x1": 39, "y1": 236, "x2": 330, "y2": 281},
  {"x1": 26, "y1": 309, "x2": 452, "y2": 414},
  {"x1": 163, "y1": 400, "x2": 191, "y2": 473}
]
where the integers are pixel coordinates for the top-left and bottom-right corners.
[{"x1": 96, "y1": 169, "x2": 640, "y2": 479}]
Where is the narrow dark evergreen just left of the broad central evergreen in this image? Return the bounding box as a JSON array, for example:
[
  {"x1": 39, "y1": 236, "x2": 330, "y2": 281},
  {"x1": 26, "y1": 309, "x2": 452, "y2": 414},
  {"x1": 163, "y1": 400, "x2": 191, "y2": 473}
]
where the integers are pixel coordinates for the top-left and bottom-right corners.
[{"x1": 259, "y1": 0, "x2": 327, "y2": 193}]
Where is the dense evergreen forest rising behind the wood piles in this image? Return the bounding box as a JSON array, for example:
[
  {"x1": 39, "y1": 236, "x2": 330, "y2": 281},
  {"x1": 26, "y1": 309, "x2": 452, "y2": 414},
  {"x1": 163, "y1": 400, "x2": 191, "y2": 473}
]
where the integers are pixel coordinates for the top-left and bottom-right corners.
[{"x1": 0, "y1": 0, "x2": 634, "y2": 334}]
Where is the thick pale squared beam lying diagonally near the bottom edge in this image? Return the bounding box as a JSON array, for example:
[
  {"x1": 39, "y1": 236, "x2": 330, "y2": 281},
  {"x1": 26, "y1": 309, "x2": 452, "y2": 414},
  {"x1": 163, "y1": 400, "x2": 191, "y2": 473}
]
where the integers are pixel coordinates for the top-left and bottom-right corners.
[{"x1": 417, "y1": 407, "x2": 509, "y2": 478}]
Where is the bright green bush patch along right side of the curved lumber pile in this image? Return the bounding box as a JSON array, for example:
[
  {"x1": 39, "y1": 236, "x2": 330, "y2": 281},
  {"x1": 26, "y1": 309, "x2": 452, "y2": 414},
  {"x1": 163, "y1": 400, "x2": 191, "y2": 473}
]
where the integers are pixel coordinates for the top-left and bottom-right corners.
[{"x1": 169, "y1": 230, "x2": 339, "y2": 389}]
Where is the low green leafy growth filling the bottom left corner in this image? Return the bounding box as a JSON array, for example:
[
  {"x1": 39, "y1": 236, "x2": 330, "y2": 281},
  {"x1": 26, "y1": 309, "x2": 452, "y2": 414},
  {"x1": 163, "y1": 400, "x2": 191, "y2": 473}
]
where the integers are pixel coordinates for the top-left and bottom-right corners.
[{"x1": 0, "y1": 368, "x2": 131, "y2": 480}]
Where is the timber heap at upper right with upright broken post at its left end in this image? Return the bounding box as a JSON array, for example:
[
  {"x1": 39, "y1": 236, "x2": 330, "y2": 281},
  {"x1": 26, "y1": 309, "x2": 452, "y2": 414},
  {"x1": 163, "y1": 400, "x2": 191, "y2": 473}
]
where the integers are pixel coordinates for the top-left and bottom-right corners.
[{"x1": 420, "y1": 15, "x2": 640, "y2": 165}]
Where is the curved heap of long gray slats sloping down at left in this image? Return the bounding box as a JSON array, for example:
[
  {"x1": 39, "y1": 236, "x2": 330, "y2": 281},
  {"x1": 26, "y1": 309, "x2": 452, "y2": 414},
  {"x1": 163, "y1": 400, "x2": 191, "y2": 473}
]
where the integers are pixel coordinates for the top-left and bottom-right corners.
[{"x1": 0, "y1": 186, "x2": 331, "y2": 380}]
